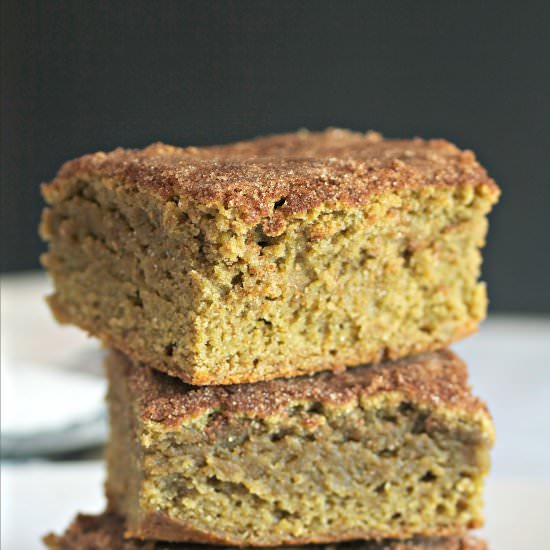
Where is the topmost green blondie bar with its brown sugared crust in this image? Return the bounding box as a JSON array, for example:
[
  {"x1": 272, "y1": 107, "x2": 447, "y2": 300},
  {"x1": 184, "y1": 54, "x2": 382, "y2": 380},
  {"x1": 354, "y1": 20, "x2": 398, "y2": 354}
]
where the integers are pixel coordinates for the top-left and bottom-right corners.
[{"x1": 41, "y1": 129, "x2": 499, "y2": 385}]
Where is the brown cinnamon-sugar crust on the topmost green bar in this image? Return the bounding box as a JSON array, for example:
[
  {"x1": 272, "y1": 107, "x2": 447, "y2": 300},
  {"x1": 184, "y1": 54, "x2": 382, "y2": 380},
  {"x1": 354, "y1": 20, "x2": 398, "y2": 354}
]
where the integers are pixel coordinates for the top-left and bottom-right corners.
[{"x1": 44, "y1": 129, "x2": 498, "y2": 232}]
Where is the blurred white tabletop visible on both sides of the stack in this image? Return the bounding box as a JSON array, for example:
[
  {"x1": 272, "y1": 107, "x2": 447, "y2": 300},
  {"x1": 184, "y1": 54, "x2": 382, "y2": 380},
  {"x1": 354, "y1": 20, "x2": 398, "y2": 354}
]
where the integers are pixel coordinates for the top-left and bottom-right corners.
[{"x1": 1, "y1": 274, "x2": 550, "y2": 550}]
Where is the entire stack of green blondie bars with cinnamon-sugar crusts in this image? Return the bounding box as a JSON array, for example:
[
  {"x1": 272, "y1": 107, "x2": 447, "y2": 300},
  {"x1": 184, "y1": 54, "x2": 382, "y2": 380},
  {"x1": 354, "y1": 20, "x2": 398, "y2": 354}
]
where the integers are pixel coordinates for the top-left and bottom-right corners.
[{"x1": 41, "y1": 129, "x2": 499, "y2": 550}]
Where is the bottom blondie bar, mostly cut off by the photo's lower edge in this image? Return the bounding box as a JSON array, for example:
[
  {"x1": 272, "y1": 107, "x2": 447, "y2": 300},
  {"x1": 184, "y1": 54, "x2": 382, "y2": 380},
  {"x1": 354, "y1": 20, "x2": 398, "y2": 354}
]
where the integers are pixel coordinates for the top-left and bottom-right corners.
[{"x1": 44, "y1": 513, "x2": 487, "y2": 550}]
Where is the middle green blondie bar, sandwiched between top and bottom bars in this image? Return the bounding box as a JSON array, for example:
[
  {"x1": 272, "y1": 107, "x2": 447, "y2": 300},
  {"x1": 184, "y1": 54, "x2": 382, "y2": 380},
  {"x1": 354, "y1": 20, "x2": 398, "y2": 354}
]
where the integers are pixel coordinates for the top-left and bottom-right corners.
[{"x1": 106, "y1": 351, "x2": 493, "y2": 546}]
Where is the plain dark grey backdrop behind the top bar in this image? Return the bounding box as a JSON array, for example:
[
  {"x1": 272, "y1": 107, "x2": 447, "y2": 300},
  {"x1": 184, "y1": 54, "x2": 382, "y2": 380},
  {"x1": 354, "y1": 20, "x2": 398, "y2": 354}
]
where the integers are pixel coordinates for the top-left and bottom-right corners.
[{"x1": 1, "y1": 0, "x2": 550, "y2": 311}]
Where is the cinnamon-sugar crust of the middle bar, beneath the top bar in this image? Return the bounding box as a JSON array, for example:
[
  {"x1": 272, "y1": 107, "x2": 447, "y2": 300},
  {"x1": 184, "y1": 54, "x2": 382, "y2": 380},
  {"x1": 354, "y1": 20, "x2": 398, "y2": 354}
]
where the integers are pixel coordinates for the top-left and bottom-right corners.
[{"x1": 111, "y1": 350, "x2": 487, "y2": 424}]
